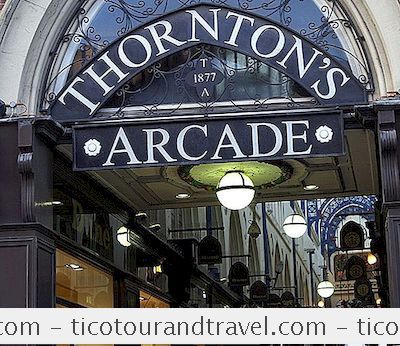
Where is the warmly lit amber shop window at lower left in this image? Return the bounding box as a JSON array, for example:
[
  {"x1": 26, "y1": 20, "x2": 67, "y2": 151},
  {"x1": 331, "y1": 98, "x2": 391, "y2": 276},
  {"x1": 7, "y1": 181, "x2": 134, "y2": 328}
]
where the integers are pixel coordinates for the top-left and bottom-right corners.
[{"x1": 56, "y1": 250, "x2": 114, "y2": 308}]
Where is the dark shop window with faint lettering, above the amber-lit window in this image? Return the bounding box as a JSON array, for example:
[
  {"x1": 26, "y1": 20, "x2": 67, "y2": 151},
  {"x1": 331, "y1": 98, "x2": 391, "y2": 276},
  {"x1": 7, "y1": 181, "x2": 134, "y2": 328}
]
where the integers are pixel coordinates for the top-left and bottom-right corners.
[{"x1": 53, "y1": 155, "x2": 130, "y2": 271}]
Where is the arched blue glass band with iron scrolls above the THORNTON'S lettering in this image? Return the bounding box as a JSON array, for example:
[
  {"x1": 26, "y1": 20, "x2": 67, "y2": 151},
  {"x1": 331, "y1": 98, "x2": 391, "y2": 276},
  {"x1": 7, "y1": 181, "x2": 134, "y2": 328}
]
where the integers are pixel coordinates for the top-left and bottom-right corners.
[{"x1": 44, "y1": 0, "x2": 371, "y2": 108}]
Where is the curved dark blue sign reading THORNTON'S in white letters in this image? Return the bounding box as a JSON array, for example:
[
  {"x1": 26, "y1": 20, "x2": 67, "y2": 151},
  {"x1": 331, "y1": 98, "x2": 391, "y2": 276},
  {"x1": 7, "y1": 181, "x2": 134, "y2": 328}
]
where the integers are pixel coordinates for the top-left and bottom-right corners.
[{"x1": 50, "y1": 4, "x2": 367, "y2": 122}]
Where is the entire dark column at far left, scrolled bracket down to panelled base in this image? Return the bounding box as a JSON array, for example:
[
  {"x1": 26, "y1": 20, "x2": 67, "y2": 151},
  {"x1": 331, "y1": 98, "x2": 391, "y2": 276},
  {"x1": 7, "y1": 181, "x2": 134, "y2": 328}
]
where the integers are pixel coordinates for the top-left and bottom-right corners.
[{"x1": 0, "y1": 121, "x2": 56, "y2": 308}]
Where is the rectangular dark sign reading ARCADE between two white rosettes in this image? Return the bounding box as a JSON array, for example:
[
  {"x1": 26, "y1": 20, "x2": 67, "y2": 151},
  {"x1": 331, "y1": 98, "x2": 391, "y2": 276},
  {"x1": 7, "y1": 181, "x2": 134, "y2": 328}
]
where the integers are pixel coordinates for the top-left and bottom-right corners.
[{"x1": 74, "y1": 111, "x2": 344, "y2": 170}]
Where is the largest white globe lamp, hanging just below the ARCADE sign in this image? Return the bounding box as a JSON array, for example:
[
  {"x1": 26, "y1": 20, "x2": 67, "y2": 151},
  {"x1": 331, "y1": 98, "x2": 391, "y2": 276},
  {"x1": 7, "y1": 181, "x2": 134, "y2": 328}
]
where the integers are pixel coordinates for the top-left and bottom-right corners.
[{"x1": 217, "y1": 171, "x2": 255, "y2": 210}]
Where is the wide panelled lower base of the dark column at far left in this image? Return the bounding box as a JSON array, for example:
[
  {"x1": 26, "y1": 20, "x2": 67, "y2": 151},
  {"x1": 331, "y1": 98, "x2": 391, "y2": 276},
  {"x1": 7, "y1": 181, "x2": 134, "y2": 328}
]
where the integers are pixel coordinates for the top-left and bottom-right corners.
[{"x1": 0, "y1": 224, "x2": 55, "y2": 308}]
